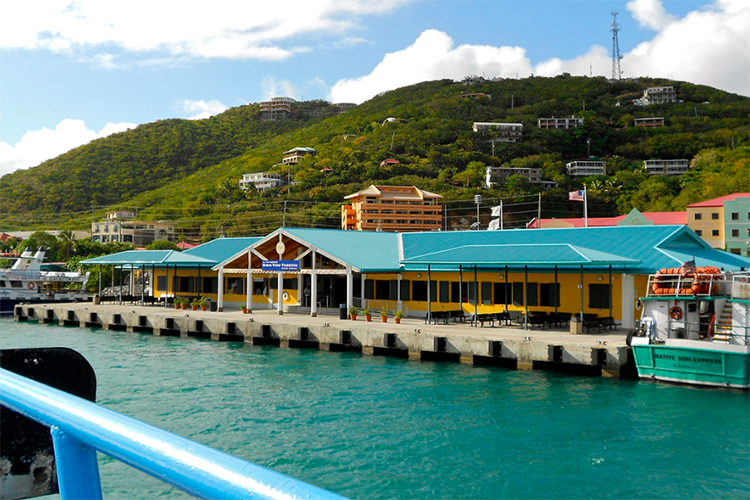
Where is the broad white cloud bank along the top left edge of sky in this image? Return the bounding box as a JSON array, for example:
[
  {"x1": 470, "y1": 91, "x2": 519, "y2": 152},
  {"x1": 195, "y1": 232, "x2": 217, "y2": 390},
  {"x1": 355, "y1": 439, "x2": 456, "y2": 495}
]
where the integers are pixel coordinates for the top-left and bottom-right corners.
[{"x1": 0, "y1": 0, "x2": 414, "y2": 64}]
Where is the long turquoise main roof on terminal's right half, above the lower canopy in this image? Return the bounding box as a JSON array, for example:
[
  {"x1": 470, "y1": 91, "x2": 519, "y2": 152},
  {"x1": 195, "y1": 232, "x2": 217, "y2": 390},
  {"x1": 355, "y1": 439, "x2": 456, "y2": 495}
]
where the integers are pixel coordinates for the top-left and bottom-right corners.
[{"x1": 400, "y1": 226, "x2": 750, "y2": 273}]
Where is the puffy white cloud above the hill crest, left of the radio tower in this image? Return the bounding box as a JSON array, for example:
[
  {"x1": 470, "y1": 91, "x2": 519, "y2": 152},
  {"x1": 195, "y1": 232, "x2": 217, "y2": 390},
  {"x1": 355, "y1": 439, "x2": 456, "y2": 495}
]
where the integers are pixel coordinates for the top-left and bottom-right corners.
[{"x1": 331, "y1": 30, "x2": 532, "y2": 102}]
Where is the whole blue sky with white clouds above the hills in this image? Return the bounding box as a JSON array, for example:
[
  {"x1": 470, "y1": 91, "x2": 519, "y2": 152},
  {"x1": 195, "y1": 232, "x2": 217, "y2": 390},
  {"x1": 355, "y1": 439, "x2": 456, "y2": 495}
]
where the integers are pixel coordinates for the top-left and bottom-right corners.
[{"x1": 0, "y1": 0, "x2": 750, "y2": 175}]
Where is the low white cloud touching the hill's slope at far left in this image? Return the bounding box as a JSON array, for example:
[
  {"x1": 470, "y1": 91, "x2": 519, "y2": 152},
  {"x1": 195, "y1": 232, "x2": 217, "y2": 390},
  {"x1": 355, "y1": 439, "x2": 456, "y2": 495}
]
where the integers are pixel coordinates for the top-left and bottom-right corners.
[{"x1": 0, "y1": 119, "x2": 136, "y2": 176}]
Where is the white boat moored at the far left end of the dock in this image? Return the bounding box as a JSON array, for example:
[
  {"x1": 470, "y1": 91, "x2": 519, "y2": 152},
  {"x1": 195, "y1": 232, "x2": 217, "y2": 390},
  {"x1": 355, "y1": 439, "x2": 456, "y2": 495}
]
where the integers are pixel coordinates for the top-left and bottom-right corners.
[{"x1": 0, "y1": 247, "x2": 89, "y2": 314}]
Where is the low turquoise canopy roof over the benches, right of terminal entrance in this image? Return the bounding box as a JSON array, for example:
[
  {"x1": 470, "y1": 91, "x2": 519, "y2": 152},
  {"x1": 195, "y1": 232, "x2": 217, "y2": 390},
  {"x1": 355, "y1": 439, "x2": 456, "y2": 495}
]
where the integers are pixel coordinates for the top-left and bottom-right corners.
[{"x1": 402, "y1": 243, "x2": 640, "y2": 269}]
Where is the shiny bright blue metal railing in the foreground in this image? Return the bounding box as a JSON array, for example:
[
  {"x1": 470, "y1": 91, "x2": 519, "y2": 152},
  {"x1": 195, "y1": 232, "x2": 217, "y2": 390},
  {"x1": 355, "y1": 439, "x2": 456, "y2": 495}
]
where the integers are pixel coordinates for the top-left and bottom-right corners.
[{"x1": 0, "y1": 369, "x2": 345, "y2": 500}]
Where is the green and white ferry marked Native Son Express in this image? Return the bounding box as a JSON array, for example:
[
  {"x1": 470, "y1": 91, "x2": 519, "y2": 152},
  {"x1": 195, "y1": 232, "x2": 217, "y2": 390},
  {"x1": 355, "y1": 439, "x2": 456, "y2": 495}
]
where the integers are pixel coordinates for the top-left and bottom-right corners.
[{"x1": 628, "y1": 263, "x2": 750, "y2": 389}]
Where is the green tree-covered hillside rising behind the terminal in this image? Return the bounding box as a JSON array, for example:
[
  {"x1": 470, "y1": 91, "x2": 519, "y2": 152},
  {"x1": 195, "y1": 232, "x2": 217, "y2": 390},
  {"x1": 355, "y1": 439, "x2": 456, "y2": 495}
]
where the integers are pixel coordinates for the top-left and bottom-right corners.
[{"x1": 0, "y1": 75, "x2": 750, "y2": 238}]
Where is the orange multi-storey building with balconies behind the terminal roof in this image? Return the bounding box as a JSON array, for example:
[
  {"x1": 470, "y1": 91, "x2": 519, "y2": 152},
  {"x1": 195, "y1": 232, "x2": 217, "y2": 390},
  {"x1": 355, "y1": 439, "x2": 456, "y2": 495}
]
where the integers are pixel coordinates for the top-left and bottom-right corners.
[{"x1": 341, "y1": 186, "x2": 443, "y2": 232}]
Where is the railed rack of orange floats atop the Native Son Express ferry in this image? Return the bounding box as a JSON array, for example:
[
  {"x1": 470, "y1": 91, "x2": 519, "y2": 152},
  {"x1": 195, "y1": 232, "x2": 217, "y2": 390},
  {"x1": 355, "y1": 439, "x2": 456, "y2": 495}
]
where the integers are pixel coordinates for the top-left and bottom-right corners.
[{"x1": 646, "y1": 273, "x2": 732, "y2": 297}]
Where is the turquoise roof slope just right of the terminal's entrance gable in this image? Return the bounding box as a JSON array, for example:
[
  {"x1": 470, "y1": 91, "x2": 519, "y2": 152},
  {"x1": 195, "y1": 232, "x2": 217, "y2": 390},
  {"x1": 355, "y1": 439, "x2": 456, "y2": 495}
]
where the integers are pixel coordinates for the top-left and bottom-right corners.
[{"x1": 283, "y1": 227, "x2": 400, "y2": 273}]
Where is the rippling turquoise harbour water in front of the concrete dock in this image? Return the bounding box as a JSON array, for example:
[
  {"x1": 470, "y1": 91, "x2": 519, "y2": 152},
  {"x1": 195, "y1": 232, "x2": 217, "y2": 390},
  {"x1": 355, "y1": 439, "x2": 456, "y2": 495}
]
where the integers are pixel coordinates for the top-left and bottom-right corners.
[{"x1": 0, "y1": 319, "x2": 750, "y2": 500}]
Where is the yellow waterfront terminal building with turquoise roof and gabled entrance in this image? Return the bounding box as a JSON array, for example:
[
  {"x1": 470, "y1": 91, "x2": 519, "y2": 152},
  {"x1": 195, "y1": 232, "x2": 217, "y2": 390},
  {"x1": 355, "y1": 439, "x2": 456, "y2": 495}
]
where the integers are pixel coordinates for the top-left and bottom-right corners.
[{"x1": 83, "y1": 225, "x2": 750, "y2": 328}]
